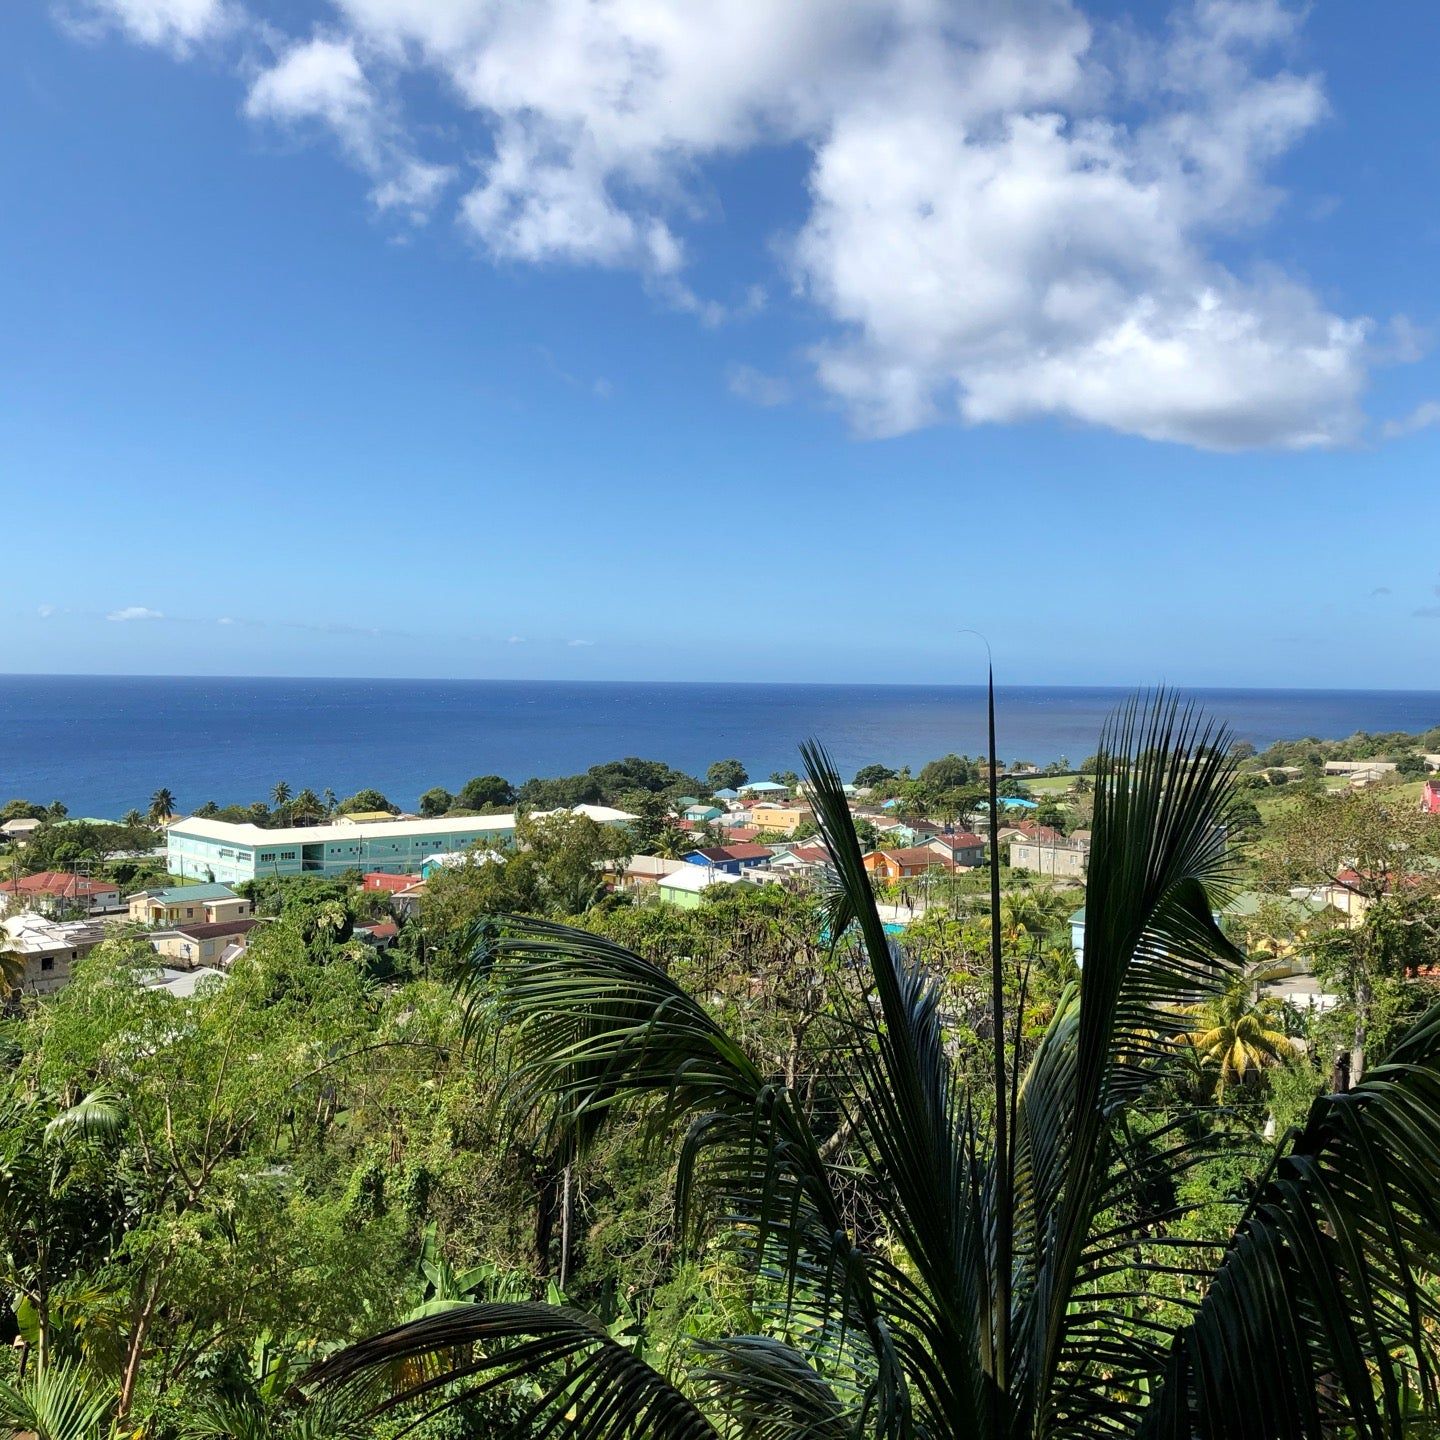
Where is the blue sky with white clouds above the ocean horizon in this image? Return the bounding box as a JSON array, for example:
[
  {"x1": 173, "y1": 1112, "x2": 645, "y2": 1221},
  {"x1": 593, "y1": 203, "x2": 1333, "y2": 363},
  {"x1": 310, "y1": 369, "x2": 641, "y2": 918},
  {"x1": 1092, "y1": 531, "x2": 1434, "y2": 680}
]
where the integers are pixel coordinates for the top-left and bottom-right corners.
[{"x1": 0, "y1": 0, "x2": 1440, "y2": 688}]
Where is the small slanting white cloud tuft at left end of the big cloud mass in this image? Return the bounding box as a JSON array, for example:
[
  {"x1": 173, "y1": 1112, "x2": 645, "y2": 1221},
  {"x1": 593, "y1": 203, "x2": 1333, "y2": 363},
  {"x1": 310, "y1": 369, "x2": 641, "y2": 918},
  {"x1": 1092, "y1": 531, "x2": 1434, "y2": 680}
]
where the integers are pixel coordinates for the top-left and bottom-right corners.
[{"x1": 245, "y1": 36, "x2": 454, "y2": 219}]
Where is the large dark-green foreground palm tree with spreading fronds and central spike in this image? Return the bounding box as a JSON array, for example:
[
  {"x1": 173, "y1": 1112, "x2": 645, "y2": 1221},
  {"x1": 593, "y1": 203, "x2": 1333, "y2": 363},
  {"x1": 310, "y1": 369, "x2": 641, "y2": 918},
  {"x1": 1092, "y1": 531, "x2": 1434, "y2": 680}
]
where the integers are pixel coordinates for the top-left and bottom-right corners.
[{"x1": 315, "y1": 698, "x2": 1440, "y2": 1440}]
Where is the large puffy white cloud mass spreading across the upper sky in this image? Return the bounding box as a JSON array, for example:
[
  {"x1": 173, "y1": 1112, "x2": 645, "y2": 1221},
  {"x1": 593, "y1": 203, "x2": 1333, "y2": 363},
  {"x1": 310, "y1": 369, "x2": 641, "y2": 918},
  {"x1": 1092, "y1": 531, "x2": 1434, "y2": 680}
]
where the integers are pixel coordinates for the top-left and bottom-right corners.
[{"x1": 59, "y1": 0, "x2": 1393, "y2": 449}]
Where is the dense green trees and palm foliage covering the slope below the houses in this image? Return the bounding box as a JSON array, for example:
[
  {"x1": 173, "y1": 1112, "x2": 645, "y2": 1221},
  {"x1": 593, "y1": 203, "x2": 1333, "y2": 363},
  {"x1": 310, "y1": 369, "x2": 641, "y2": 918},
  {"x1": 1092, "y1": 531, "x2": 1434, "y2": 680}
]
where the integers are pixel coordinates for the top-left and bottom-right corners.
[{"x1": 8, "y1": 714, "x2": 1440, "y2": 1440}]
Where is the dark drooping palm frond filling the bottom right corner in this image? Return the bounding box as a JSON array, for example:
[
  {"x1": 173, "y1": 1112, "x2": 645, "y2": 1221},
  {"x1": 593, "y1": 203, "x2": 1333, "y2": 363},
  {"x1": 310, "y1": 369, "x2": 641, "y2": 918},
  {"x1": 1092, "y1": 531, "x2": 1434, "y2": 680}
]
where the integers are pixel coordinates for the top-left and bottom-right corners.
[{"x1": 1143, "y1": 1007, "x2": 1440, "y2": 1437}]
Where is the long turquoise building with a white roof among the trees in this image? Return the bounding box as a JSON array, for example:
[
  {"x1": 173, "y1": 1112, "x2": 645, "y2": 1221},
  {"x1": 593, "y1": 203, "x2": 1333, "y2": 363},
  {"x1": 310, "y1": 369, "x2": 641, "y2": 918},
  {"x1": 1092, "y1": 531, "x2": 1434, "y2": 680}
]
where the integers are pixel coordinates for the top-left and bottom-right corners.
[{"x1": 166, "y1": 815, "x2": 516, "y2": 884}]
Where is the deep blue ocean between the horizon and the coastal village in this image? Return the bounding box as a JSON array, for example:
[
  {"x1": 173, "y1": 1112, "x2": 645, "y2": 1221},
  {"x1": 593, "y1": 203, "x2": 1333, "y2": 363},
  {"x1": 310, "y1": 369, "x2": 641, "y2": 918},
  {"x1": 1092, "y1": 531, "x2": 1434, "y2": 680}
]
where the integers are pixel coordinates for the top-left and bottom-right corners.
[{"x1": 0, "y1": 675, "x2": 1440, "y2": 816}]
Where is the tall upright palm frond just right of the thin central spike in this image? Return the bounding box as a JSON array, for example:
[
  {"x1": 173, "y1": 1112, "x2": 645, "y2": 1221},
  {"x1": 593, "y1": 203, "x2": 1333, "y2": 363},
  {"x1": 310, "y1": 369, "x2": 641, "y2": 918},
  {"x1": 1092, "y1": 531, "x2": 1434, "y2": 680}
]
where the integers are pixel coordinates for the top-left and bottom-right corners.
[{"x1": 1017, "y1": 694, "x2": 1244, "y2": 1428}]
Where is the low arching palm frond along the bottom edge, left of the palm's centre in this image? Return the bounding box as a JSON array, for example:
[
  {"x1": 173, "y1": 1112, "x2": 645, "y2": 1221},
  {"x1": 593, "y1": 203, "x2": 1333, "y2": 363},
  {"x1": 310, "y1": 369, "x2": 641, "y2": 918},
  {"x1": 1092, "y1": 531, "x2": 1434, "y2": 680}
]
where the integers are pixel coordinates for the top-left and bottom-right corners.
[{"x1": 310, "y1": 1303, "x2": 716, "y2": 1440}]
